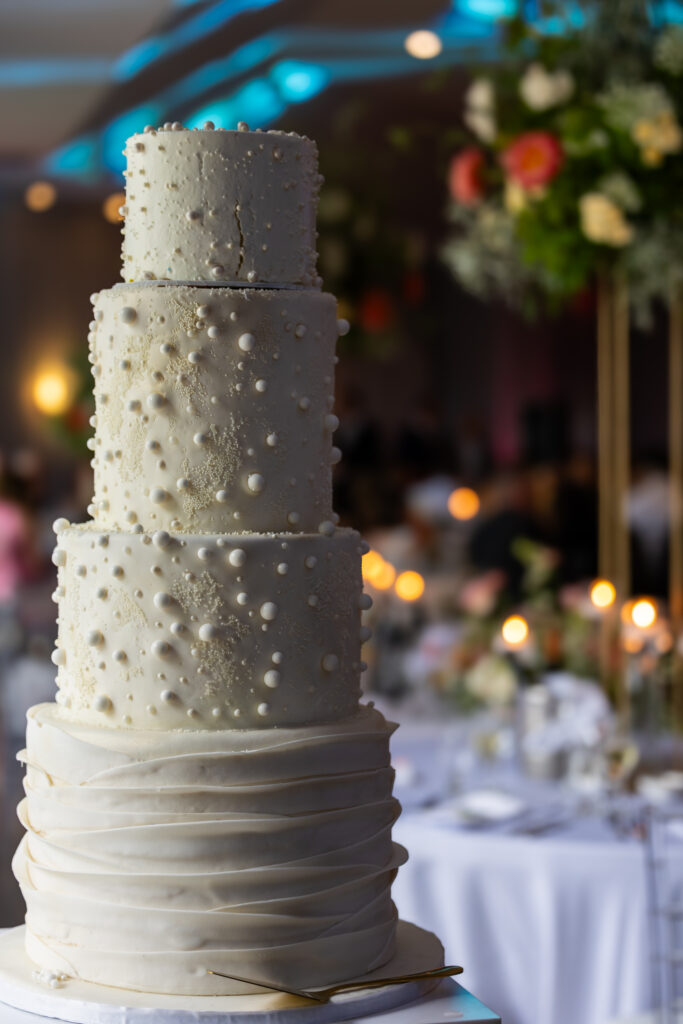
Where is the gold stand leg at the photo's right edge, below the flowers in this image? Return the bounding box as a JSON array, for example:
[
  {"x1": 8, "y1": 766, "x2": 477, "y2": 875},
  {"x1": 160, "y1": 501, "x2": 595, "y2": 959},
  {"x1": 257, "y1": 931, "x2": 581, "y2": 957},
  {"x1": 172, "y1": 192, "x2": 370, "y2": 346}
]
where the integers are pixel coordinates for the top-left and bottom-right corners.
[{"x1": 669, "y1": 282, "x2": 683, "y2": 729}]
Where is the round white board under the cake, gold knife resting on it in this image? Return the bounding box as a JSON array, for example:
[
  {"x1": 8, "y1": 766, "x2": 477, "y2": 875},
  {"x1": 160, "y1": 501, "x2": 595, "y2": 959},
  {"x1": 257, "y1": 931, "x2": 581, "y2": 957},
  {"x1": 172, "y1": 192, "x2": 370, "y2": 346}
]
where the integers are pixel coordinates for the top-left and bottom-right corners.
[{"x1": 0, "y1": 921, "x2": 443, "y2": 1024}]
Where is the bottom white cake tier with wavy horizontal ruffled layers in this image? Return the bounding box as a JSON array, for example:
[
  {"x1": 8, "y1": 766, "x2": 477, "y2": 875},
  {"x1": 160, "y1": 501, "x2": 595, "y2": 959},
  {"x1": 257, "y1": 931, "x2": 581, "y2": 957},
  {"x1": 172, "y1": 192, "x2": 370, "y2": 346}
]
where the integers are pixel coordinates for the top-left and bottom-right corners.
[{"x1": 13, "y1": 705, "x2": 405, "y2": 995}]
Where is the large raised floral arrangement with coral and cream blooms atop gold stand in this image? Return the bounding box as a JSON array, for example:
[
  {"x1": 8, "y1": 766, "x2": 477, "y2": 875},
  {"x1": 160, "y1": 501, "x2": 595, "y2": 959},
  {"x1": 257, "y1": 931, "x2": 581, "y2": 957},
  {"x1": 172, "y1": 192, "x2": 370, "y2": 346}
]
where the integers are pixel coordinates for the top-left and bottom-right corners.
[{"x1": 443, "y1": 0, "x2": 683, "y2": 316}]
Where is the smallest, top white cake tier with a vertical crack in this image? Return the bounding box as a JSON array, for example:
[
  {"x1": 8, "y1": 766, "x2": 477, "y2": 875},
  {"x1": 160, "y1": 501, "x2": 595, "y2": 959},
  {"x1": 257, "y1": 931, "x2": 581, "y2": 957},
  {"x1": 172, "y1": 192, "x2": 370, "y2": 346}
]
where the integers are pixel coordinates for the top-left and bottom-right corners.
[{"x1": 121, "y1": 125, "x2": 322, "y2": 288}]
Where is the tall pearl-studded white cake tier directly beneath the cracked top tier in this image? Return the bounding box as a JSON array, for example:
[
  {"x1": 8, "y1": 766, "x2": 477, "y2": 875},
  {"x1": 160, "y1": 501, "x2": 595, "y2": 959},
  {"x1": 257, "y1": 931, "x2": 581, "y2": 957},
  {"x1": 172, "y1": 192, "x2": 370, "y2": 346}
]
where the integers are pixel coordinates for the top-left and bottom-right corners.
[{"x1": 90, "y1": 284, "x2": 338, "y2": 532}]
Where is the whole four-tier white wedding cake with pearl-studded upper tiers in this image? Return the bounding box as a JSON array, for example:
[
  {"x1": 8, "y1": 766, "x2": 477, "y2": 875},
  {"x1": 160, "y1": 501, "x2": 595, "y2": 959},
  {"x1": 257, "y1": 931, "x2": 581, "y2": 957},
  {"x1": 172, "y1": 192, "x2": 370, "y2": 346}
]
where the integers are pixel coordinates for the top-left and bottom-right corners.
[{"x1": 13, "y1": 124, "x2": 405, "y2": 995}]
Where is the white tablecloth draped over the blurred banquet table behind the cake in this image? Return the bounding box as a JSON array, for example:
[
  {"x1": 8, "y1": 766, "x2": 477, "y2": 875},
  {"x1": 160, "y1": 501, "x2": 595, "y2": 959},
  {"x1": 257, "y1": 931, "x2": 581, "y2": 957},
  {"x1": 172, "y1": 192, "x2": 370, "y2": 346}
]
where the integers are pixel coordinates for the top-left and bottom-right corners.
[{"x1": 382, "y1": 708, "x2": 650, "y2": 1024}]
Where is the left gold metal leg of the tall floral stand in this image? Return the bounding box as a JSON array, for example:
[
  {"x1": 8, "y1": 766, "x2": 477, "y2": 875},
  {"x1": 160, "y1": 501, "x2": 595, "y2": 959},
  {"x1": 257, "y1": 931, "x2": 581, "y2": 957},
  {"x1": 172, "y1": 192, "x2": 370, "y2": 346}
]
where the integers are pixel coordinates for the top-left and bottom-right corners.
[{"x1": 598, "y1": 274, "x2": 631, "y2": 725}]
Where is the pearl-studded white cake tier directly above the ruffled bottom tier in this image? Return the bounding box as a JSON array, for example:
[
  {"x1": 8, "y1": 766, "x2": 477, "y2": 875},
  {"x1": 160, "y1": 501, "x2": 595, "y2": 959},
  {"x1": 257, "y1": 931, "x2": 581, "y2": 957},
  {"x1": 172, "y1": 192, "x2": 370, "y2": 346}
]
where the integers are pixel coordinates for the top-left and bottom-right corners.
[{"x1": 53, "y1": 525, "x2": 368, "y2": 729}]
